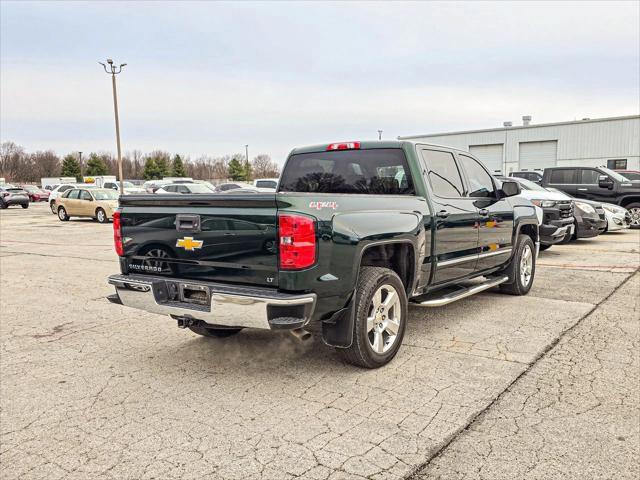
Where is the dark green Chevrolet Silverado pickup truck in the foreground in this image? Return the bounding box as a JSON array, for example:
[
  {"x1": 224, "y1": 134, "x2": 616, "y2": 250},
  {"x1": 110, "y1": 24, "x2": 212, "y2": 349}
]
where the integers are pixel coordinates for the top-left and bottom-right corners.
[{"x1": 109, "y1": 141, "x2": 539, "y2": 368}]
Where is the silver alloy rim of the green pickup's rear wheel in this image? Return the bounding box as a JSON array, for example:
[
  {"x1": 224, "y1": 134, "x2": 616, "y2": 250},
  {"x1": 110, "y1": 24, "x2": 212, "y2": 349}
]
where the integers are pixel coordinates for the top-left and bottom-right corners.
[{"x1": 367, "y1": 285, "x2": 402, "y2": 354}]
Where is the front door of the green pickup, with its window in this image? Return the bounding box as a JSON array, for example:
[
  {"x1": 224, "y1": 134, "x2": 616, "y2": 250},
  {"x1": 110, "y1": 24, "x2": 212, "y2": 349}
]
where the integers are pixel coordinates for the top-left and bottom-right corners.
[{"x1": 458, "y1": 154, "x2": 513, "y2": 271}]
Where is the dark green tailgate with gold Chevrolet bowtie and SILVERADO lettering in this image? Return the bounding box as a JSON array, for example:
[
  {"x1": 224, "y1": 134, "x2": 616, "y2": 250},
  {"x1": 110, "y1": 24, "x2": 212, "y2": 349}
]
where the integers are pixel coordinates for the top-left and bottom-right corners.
[{"x1": 120, "y1": 193, "x2": 278, "y2": 287}]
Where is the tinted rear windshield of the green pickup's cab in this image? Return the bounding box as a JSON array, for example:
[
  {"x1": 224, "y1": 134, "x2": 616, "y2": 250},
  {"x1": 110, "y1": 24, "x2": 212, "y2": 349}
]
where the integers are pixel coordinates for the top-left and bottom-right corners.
[{"x1": 280, "y1": 148, "x2": 415, "y2": 195}]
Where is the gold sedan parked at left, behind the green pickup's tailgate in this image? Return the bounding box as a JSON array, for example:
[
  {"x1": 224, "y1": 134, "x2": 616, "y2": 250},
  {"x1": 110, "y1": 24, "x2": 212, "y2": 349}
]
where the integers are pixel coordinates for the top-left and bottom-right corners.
[{"x1": 56, "y1": 188, "x2": 118, "y2": 223}]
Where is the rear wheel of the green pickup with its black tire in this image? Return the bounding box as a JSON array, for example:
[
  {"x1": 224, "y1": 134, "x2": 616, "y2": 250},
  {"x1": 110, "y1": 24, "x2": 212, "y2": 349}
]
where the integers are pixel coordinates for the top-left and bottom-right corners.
[{"x1": 336, "y1": 267, "x2": 408, "y2": 368}]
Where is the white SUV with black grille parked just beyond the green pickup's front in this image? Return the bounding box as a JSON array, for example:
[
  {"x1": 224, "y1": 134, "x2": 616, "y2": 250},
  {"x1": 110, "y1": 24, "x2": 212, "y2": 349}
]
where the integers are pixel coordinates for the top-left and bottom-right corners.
[{"x1": 497, "y1": 176, "x2": 575, "y2": 250}]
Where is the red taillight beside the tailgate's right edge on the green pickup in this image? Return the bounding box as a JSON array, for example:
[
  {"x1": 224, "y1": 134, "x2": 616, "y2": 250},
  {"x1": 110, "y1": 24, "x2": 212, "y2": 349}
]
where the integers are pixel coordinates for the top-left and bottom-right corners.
[{"x1": 278, "y1": 214, "x2": 316, "y2": 270}]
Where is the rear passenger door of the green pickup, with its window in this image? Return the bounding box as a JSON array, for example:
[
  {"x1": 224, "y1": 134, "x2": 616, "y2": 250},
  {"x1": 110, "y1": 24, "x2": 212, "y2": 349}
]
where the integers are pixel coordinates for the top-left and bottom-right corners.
[{"x1": 420, "y1": 147, "x2": 479, "y2": 283}]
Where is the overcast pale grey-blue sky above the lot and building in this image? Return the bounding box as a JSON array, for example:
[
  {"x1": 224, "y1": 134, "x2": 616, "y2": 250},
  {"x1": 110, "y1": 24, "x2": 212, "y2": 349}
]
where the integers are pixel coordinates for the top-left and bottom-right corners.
[{"x1": 0, "y1": 1, "x2": 640, "y2": 162}]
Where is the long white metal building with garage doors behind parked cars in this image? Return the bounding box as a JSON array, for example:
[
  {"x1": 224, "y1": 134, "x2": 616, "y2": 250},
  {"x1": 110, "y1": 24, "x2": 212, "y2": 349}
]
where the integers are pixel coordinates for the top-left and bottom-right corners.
[{"x1": 398, "y1": 115, "x2": 640, "y2": 172}]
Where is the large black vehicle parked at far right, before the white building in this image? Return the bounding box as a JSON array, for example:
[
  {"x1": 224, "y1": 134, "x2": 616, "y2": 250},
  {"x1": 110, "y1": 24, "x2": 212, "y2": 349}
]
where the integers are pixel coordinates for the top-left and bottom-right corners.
[{"x1": 542, "y1": 167, "x2": 640, "y2": 228}]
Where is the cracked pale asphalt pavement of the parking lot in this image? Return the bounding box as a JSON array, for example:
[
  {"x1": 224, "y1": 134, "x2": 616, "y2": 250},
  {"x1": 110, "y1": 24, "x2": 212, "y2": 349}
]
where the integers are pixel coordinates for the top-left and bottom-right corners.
[{"x1": 0, "y1": 204, "x2": 640, "y2": 480}]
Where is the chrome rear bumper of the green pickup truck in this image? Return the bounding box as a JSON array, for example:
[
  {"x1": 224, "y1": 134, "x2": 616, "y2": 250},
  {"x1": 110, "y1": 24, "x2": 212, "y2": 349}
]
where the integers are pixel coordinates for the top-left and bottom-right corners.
[{"x1": 109, "y1": 275, "x2": 316, "y2": 329}]
